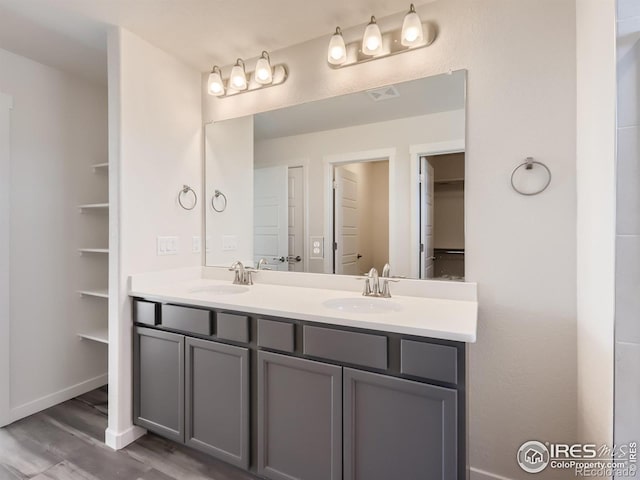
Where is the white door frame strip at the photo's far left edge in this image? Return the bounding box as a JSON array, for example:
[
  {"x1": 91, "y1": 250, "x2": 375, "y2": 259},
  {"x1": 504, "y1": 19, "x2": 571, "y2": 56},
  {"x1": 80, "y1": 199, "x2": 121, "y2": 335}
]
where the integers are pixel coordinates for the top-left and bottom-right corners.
[{"x1": 0, "y1": 92, "x2": 13, "y2": 427}]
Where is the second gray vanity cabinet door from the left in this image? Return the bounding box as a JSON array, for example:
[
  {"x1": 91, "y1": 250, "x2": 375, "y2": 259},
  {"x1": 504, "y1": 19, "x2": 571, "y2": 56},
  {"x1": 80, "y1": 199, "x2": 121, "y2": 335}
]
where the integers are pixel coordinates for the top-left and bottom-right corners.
[{"x1": 185, "y1": 338, "x2": 249, "y2": 468}]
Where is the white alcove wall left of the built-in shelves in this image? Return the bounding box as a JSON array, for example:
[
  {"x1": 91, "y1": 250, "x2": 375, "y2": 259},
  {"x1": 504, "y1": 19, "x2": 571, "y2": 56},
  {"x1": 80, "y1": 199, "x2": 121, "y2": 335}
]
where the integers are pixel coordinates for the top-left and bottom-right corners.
[{"x1": 0, "y1": 50, "x2": 107, "y2": 420}]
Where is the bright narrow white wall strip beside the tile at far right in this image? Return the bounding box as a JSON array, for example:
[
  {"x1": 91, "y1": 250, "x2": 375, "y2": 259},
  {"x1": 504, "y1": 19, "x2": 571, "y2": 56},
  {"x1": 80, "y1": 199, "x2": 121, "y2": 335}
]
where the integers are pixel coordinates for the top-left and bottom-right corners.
[{"x1": 576, "y1": 0, "x2": 616, "y2": 454}]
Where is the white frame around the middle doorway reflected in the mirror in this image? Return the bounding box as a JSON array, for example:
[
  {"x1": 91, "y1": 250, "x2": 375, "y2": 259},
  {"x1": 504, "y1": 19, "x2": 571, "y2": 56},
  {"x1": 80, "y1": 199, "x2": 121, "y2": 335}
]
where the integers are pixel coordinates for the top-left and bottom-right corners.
[{"x1": 322, "y1": 148, "x2": 398, "y2": 273}]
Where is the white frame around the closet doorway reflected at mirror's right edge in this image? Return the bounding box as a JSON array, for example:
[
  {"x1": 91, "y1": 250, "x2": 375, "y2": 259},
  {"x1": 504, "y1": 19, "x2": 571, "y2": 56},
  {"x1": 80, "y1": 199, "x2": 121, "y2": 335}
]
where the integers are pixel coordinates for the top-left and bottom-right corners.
[{"x1": 410, "y1": 138, "x2": 468, "y2": 279}]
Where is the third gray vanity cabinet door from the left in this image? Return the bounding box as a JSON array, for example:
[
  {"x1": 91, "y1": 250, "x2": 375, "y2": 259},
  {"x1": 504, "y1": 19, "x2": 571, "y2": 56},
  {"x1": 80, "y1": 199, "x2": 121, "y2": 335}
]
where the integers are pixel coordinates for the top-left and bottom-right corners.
[{"x1": 258, "y1": 351, "x2": 342, "y2": 480}]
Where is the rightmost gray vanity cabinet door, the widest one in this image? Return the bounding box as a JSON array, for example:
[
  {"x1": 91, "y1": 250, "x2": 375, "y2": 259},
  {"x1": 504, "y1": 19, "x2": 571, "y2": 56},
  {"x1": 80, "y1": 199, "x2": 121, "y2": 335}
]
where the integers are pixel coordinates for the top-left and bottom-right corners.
[{"x1": 343, "y1": 368, "x2": 457, "y2": 480}]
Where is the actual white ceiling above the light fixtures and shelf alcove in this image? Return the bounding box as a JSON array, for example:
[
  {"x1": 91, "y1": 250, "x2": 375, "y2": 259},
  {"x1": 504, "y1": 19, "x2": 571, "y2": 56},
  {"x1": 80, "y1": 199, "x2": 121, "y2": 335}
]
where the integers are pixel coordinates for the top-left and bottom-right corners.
[{"x1": 0, "y1": 0, "x2": 424, "y2": 81}]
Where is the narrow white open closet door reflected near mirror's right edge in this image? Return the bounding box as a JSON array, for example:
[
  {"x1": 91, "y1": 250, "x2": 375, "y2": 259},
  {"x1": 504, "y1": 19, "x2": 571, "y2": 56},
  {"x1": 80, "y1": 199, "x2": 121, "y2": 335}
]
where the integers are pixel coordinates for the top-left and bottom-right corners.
[{"x1": 420, "y1": 157, "x2": 435, "y2": 278}]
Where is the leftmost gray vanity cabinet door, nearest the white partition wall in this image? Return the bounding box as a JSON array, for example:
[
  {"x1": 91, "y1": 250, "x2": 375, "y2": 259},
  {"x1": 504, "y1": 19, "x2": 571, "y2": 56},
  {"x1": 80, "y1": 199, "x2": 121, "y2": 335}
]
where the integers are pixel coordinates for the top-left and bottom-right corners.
[{"x1": 133, "y1": 327, "x2": 184, "y2": 442}]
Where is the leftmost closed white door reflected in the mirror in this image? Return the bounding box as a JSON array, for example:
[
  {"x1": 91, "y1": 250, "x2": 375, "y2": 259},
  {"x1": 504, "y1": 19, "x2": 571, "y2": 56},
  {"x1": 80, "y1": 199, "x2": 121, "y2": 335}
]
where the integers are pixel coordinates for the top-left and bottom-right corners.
[{"x1": 253, "y1": 166, "x2": 289, "y2": 270}]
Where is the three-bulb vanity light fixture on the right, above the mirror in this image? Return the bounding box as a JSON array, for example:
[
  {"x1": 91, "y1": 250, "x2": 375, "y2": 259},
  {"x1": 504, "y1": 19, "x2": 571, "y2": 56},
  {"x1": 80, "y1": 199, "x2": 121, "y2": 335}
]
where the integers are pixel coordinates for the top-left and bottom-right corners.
[{"x1": 327, "y1": 4, "x2": 435, "y2": 68}]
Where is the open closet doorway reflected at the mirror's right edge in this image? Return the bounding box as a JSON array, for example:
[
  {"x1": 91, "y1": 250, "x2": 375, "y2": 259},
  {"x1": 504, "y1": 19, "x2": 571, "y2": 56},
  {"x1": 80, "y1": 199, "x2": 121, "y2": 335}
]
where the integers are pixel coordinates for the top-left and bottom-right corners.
[{"x1": 420, "y1": 152, "x2": 465, "y2": 280}]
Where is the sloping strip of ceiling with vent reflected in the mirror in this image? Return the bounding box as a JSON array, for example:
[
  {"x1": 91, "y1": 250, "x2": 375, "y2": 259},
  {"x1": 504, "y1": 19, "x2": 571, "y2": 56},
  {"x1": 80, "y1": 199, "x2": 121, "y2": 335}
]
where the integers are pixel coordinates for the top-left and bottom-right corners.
[{"x1": 254, "y1": 71, "x2": 465, "y2": 140}]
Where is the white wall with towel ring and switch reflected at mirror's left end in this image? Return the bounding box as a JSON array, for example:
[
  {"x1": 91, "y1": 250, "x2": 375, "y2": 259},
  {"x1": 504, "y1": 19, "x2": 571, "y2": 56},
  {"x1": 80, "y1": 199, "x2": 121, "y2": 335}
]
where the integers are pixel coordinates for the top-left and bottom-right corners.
[{"x1": 204, "y1": 117, "x2": 254, "y2": 267}]
